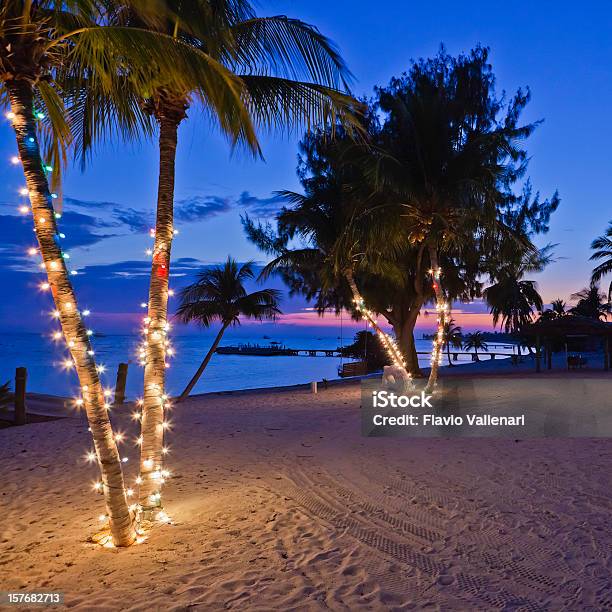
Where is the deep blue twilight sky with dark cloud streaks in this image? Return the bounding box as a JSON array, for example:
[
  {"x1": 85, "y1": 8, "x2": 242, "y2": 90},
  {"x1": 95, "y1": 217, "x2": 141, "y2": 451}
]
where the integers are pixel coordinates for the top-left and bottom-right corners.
[{"x1": 0, "y1": 0, "x2": 612, "y2": 330}]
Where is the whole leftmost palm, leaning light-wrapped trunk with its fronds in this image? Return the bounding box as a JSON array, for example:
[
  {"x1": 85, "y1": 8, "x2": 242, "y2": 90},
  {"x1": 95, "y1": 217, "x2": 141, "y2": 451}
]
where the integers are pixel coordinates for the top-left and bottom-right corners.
[{"x1": 0, "y1": 0, "x2": 215, "y2": 546}]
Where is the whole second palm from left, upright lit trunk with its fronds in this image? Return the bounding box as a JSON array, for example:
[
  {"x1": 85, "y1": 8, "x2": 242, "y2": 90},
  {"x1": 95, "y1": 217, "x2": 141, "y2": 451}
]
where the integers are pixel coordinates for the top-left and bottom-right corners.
[{"x1": 128, "y1": 0, "x2": 355, "y2": 512}]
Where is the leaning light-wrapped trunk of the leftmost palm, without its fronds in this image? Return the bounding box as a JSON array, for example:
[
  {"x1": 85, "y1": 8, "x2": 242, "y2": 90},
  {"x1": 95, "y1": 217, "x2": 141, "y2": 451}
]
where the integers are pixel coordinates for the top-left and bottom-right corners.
[{"x1": 6, "y1": 80, "x2": 136, "y2": 546}]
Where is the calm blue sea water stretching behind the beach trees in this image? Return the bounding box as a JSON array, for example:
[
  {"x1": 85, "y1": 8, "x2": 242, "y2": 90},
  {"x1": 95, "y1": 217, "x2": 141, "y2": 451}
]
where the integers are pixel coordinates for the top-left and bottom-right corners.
[{"x1": 0, "y1": 327, "x2": 511, "y2": 399}]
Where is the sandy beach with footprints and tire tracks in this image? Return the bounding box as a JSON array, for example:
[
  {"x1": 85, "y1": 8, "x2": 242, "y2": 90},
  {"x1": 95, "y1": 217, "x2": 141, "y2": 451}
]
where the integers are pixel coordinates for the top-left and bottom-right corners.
[{"x1": 0, "y1": 380, "x2": 612, "y2": 611}]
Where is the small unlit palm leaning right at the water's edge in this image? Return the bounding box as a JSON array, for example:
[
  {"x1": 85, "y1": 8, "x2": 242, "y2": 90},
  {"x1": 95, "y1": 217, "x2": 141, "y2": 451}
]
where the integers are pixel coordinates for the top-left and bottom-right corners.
[{"x1": 176, "y1": 257, "x2": 281, "y2": 400}]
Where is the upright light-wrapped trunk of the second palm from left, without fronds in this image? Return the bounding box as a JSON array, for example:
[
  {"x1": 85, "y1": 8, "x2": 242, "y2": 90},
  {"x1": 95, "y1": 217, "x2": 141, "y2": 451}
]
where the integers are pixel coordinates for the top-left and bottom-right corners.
[{"x1": 139, "y1": 108, "x2": 184, "y2": 519}]
